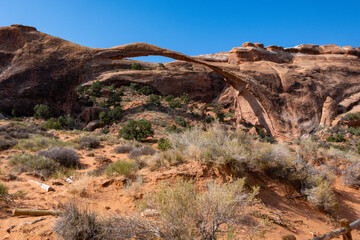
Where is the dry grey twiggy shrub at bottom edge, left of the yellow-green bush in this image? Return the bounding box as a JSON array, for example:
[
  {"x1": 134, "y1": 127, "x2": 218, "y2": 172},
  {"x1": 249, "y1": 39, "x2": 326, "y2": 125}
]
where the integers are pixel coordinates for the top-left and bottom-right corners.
[{"x1": 53, "y1": 202, "x2": 160, "y2": 240}]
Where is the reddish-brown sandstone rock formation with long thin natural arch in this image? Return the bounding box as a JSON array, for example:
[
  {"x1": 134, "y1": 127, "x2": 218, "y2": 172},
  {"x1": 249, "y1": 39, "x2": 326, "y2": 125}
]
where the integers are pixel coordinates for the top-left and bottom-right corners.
[{"x1": 0, "y1": 25, "x2": 360, "y2": 139}]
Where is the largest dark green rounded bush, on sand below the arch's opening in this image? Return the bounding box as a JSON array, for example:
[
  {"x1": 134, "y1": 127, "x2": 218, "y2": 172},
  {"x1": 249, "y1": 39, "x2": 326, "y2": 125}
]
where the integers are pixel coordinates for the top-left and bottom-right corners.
[{"x1": 119, "y1": 120, "x2": 154, "y2": 141}]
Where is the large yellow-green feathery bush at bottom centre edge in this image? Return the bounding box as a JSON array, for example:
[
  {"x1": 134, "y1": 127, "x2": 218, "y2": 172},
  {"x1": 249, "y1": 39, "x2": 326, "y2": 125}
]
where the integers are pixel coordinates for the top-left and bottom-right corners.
[{"x1": 141, "y1": 179, "x2": 258, "y2": 239}]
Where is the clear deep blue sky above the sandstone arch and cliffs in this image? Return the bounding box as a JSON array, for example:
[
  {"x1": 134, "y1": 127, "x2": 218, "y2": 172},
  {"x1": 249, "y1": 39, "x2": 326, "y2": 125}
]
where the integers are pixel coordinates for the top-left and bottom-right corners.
[{"x1": 0, "y1": 0, "x2": 360, "y2": 60}]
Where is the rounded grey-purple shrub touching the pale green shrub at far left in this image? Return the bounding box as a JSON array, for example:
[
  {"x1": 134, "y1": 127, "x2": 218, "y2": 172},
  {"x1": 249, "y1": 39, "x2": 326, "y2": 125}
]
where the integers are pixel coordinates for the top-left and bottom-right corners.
[{"x1": 38, "y1": 147, "x2": 80, "y2": 167}]
